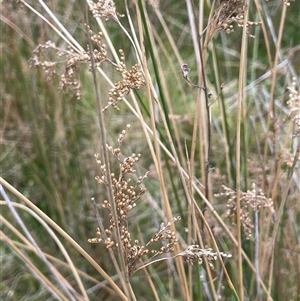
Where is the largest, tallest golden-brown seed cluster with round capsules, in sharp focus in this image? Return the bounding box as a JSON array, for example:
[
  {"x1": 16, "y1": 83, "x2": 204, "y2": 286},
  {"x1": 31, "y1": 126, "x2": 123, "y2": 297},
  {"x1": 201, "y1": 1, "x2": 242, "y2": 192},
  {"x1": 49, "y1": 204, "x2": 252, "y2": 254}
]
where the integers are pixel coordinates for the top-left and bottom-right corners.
[{"x1": 88, "y1": 125, "x2": 180, "y2": 276}]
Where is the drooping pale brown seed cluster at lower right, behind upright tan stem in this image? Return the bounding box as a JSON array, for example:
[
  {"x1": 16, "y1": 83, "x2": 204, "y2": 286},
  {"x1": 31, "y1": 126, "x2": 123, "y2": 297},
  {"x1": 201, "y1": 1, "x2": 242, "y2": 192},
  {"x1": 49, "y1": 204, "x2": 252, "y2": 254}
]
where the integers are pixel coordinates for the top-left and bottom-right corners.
[{"x1": 215, "y1": 184, "x2": 275, "y2": 239}]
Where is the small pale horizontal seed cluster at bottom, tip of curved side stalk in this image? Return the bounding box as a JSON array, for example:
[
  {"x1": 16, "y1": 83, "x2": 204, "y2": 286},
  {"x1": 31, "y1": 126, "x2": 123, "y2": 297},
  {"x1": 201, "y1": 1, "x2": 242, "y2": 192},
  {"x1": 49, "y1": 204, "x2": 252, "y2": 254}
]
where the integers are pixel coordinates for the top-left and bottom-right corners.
[{"x1": 178, "y1": 245, "x2": 232, "y2": 270}]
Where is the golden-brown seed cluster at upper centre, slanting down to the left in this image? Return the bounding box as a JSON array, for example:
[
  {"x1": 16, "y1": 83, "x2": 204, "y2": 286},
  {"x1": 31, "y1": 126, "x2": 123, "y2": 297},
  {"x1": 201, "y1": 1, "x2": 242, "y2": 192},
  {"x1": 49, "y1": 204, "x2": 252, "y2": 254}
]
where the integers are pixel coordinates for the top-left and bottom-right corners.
[{"x1": 103, "y1": 50, "x2": 146, "y2": 111}]
